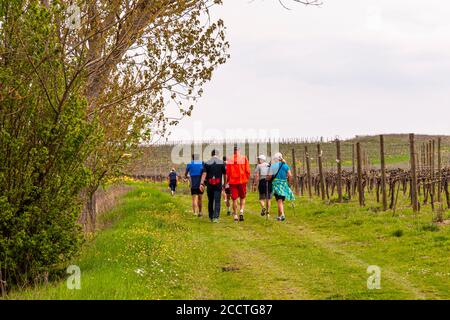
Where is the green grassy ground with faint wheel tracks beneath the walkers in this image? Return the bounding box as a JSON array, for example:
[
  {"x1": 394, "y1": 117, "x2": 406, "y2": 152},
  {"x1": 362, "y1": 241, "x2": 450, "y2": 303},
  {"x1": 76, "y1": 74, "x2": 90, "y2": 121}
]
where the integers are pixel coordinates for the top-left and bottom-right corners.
[{"x1": 8, "y1": 182, "x2": 450, "y2": 299}]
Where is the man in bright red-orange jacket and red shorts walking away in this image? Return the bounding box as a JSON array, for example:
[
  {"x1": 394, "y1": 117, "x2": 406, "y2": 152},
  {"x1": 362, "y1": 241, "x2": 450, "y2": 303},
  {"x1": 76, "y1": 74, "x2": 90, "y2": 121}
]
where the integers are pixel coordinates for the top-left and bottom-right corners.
[{"x1": 226, "y1": 147, "x2": 250, "y2": 221}]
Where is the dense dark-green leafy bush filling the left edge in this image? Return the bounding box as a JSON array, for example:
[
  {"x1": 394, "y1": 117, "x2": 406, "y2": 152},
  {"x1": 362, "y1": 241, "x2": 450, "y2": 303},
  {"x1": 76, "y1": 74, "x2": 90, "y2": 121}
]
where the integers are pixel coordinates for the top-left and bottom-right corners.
[{"x1": 0, "y1": 1, "x2": 95, "y2": 287}]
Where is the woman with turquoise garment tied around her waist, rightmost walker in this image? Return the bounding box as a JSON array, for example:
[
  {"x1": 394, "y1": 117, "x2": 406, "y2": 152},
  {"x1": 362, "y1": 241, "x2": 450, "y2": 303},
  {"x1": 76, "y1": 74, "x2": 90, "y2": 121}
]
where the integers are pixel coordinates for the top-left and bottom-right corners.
[{"x1": 267, "y1": 152, "x2": 295, "y2": 221}]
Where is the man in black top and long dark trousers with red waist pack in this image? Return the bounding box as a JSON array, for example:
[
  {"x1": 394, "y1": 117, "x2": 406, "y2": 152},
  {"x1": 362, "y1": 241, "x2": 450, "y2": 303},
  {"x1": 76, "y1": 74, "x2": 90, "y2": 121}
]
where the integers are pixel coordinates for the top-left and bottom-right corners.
[{"x1": 200, "y1": 150, "x2": 227, "y2": 222}]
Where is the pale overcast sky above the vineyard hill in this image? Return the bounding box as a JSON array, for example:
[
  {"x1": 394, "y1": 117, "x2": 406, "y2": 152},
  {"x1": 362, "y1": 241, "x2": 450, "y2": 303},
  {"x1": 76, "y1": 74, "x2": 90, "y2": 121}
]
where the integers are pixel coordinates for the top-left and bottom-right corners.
[{"x1": 171, "y1": 0, "x2": 450, "y2": 139}]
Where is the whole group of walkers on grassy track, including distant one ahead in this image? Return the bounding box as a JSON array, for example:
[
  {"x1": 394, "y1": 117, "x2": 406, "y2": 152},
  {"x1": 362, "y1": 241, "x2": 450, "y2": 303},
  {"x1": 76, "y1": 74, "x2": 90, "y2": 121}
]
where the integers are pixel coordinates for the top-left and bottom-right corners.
[{"x1": 168, "y1": 147, "x2": 294, "y2": 223}]
